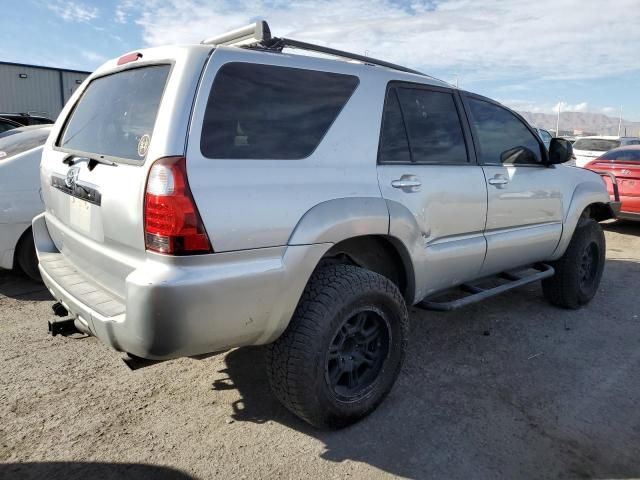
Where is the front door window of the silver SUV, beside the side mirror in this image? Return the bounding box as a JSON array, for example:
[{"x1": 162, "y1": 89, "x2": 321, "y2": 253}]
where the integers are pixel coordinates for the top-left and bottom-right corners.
[{"x1": 469, "y1": 98, "x2": 542, "y2": 164}]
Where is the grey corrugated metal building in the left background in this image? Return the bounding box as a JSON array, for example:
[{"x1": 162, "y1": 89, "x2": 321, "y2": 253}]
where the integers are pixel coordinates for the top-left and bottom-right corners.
[{"x1": 0, "y1": 62, "x2": 90, "y2": 120}]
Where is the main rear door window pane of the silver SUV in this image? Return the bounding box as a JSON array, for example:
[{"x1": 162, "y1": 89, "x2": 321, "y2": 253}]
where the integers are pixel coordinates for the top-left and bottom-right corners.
[{"x1": 398, "y1": 88, "x2": 467, "y2": 163}]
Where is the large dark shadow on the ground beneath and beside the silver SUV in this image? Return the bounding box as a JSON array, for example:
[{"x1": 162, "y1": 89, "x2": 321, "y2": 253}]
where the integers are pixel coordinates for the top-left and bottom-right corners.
[{"x1": 213, "y1": 260, "x2": 640, "y2": 479}]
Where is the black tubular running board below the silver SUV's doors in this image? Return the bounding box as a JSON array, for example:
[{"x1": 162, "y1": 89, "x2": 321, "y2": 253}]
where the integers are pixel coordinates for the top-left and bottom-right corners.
[{"x1": 416, "y1": 263, "x2": 555, "y2": 312}]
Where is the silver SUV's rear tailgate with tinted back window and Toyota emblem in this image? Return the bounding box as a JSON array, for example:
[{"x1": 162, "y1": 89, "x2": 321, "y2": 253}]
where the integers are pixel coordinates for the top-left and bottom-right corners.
[{"x1": 41, "y1": 46, "x2": 211, "y2": 299}]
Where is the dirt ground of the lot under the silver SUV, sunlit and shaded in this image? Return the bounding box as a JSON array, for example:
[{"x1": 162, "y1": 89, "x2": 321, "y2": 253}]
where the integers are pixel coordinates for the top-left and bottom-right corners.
[{"x1": 0, "y1": 223, "x2": 640, "y2": 479}]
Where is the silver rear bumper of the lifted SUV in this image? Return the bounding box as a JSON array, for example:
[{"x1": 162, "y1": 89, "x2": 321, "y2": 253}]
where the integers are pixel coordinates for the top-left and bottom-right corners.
[{"x1": 33, "y1": 214, "x2": 330, "y2": 360}]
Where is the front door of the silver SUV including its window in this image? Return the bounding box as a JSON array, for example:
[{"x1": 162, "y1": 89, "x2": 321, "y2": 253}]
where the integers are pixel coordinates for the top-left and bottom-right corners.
[{"x1": 464, "y1": 94, "x2": 563, "y2": 275}]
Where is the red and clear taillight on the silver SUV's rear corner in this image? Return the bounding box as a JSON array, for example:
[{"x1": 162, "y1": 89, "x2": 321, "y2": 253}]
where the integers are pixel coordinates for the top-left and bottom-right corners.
[{"x1": 144, "y1": 157, "x2": 213, "y2": 255}]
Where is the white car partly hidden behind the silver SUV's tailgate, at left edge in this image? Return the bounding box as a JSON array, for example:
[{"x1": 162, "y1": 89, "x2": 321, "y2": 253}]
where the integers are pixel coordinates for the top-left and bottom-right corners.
[{"x1": 0, "y1": 125, "x2": 51, "y2": 281}]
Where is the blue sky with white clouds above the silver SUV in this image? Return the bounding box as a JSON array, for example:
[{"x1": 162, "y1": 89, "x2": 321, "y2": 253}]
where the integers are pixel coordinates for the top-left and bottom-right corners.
[{"x1": 0, "y1": 0, "x2": 640, "y2": 121}]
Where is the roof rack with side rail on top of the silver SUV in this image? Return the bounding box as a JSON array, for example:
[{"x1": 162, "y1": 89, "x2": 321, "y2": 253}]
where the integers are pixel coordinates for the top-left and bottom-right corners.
[{"x1": 201, "y1": 20, "x2": 446, "y2": 83}]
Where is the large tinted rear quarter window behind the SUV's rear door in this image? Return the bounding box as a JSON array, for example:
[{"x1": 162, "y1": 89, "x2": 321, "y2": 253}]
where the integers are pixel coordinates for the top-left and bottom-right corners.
[{"x1": 200, "y1": 63, "x2": 358, "y2": 160}]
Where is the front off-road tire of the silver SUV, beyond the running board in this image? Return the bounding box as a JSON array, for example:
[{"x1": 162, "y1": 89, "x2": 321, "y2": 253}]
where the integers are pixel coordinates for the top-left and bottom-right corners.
[{"x1": 542, "y1": 218, "x2": 606, "y2": 309}]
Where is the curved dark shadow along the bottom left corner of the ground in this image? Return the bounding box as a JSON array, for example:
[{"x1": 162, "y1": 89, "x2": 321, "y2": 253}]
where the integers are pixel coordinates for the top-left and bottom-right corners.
[{"x1": 0, "y1": 462, "x2": 193, "y2": 480}]
